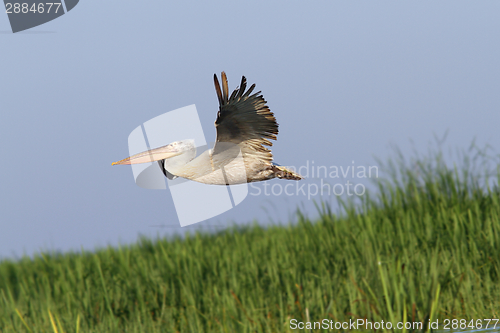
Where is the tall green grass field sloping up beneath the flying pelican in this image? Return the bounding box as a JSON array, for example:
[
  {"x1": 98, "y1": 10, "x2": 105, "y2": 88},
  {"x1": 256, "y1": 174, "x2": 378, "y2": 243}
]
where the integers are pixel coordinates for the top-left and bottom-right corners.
[{"x1": 0, "y1": 148, "x2": 500, "y2": 332}]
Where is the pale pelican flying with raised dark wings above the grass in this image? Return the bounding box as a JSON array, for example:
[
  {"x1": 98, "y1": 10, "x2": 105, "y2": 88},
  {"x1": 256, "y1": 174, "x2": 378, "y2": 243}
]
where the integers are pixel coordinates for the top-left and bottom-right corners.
[{"x1": 112, "y1": 72, "x2": 302, "y2": 185}]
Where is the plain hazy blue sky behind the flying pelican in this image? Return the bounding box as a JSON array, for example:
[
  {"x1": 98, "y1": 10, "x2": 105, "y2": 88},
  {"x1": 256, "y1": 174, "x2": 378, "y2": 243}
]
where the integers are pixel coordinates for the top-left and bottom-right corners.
[{"x1": 0, "y1": 0, "x2": 500, "y2": 257}]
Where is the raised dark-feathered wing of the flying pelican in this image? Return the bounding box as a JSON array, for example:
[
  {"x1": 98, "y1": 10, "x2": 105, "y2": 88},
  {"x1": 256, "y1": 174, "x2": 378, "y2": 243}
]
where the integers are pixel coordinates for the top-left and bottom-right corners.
[{"x1": 214, "y1": 72, "x2": 278, "y2": 163}]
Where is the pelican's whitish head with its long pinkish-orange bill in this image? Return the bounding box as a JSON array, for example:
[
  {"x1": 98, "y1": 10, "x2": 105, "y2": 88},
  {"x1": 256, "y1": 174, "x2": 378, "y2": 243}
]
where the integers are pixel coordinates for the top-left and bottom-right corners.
[{"x1": 111, "y1": 140, "x2": 196, "y2": 167}]
